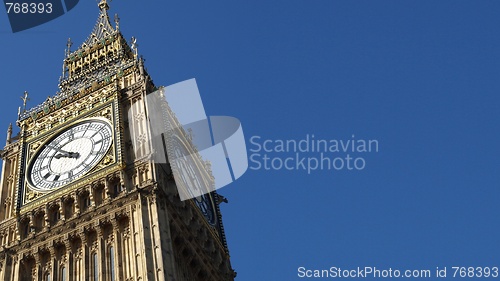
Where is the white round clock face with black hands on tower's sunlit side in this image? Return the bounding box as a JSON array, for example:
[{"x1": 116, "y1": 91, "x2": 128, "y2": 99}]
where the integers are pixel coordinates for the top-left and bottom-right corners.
[{"x1": 28, "y1": 119, "x2": 112, "y2": 191}]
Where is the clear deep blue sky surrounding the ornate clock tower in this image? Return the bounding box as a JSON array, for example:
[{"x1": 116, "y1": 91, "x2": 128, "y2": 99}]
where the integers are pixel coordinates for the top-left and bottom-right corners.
[{"x1": 0, "y1": 0, "x2": 500, "y2": 281}]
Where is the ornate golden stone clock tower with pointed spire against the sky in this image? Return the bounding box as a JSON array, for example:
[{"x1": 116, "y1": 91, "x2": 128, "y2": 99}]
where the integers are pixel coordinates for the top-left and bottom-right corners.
[{"x1": 0, "y1": 0, "x2": 235, "y2": 281}]
